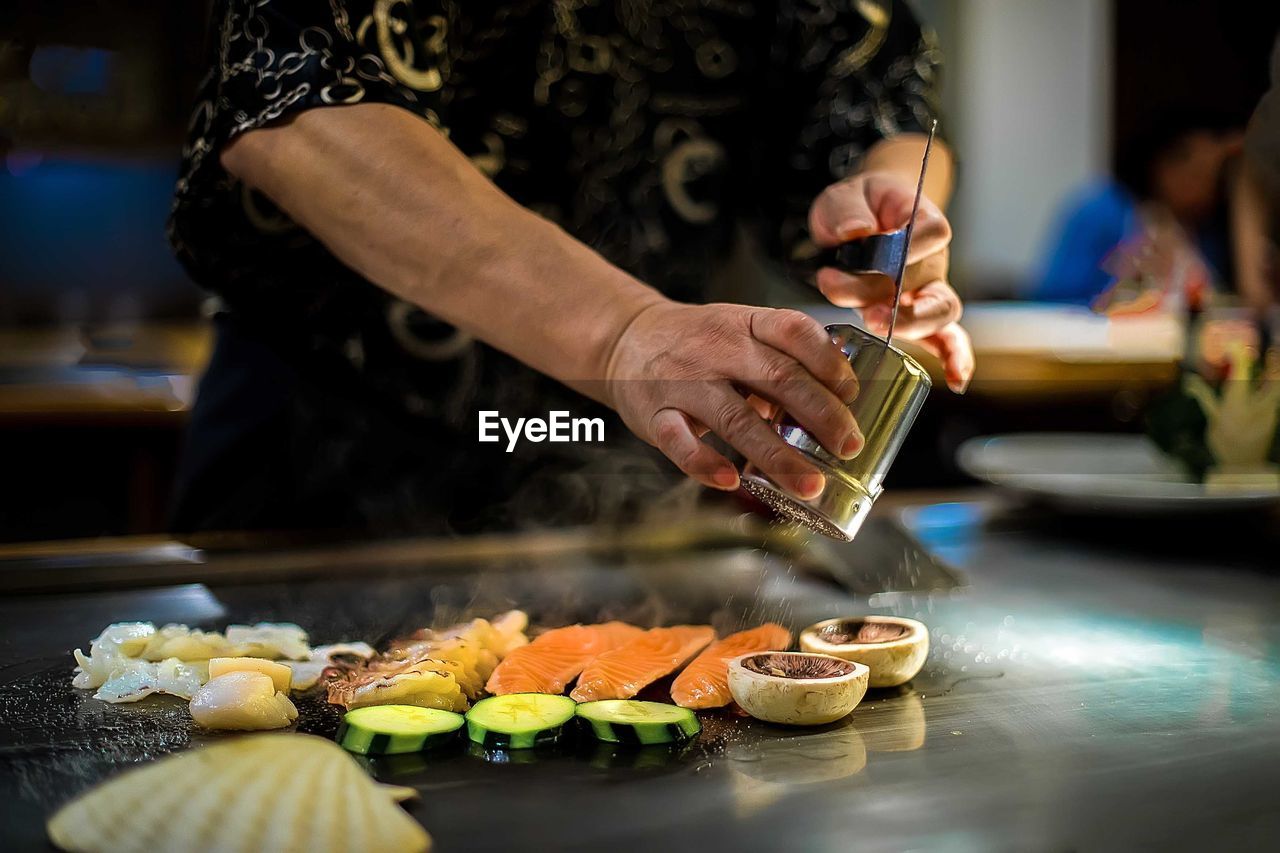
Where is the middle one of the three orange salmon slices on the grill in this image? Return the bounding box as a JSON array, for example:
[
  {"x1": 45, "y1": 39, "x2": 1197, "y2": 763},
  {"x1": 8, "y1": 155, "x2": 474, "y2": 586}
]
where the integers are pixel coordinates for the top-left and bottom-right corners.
[{"x1": 570, "y1": 625, "x2": 716, "y2": 702}]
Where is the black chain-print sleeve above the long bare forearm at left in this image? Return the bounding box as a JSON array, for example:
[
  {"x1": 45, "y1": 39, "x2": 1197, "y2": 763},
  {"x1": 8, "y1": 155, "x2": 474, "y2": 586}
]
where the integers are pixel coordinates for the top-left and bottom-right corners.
[{"x1": 169, "y1": 0, "x2": 435, "y2": 289}]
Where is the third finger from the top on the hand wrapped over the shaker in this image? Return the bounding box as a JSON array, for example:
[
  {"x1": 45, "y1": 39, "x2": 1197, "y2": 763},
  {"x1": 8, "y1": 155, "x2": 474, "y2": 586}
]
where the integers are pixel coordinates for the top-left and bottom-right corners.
[{"x1": 685, "y1": 386, "x2": 824, "y2": 501}]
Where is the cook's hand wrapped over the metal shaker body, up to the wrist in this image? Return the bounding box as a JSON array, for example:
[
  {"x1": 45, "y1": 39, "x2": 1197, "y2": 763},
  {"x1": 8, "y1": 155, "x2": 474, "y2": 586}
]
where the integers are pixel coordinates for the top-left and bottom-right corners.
[{"x1": 607, "y1": 301, "x2": 863, "y2": 498}]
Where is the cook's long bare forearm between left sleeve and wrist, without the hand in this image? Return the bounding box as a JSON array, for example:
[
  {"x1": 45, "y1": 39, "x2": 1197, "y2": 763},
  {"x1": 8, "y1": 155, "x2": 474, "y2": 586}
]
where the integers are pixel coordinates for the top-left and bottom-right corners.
[{"x1": 223, "y1": 104, "x2": 663, "y2": 397}]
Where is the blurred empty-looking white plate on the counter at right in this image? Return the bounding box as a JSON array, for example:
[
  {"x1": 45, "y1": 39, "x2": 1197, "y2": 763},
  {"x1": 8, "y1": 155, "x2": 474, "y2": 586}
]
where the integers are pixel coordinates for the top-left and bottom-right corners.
[{"x1": 956, "y1": 433, "x2": 1280, "y2": 514}]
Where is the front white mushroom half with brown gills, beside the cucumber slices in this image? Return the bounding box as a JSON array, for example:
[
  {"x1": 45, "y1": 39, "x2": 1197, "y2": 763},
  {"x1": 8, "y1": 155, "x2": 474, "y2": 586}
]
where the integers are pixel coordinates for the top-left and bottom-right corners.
[{"x1": 728, "y1": 652, "x2": 868, "y2": 726}]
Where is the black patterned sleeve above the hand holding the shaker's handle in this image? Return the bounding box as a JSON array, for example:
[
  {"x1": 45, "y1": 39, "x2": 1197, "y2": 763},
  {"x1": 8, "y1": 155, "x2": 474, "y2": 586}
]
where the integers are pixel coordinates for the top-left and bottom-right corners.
[{"x1": 758, "y1": 0, "x2": 942, "y2": 266}]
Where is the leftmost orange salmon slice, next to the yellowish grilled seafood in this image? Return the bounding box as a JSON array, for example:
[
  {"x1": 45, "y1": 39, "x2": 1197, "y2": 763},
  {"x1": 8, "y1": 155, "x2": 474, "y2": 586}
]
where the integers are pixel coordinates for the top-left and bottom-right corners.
[{"x1": 485, "y1": 622, "x2": 644, "y2": 695}]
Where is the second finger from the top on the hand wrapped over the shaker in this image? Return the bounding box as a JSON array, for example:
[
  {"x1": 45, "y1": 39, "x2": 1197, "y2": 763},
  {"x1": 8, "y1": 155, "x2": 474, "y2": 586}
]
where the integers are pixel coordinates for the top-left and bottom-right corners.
[{"x1": 737, "y1": 347, "x2": 865, "y2": 459}]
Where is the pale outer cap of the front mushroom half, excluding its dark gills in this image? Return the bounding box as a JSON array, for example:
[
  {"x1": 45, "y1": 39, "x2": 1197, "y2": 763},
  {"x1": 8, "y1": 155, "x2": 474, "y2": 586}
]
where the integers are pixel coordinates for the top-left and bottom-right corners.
[{"x1": 728, "y1": 652, "x2": 868, "y2": 726}]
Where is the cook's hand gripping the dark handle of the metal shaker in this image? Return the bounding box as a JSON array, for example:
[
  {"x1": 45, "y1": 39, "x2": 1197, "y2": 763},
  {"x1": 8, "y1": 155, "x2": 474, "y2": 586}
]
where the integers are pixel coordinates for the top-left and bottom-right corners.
[{"x1": 809, "y1": 170, "x2": 974, "y2": 393}]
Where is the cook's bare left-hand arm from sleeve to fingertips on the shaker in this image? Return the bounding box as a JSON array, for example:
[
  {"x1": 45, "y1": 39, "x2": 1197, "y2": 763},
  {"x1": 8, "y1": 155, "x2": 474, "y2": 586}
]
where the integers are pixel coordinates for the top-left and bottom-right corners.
[{"x1": 221, "y1": 104, "x2": 861, "y2": 497}]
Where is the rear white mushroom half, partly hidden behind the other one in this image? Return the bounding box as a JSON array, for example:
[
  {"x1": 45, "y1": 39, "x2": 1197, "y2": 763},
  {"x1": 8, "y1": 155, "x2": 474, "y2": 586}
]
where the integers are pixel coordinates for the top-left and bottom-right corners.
[{"x1": 800, "y1": 616, "x2": 929, "y2": 688}]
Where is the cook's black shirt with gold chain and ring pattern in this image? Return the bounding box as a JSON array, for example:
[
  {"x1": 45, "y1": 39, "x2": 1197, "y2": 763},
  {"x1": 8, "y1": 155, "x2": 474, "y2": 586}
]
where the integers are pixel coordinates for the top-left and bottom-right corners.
[{"x1": 170, "y1": 0, "x2": 940, "y2": 528}]
